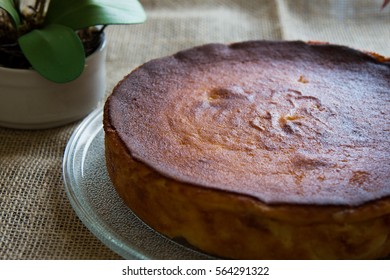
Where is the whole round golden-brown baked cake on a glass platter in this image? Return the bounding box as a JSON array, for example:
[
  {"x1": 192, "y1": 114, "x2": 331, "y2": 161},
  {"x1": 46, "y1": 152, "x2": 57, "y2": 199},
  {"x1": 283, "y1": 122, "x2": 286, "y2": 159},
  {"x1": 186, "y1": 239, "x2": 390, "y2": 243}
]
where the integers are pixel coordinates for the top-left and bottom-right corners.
[{"x1": 103, "y1": 41, "x2": 390, "y2": 259}]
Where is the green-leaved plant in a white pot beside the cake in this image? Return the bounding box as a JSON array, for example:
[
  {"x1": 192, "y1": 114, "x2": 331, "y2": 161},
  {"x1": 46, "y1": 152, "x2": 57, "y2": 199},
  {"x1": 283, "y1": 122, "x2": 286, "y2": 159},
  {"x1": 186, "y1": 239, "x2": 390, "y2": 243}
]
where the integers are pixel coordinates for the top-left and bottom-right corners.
[{"x1": 0, "y1": 0, "x2": 146, "y2": 129}]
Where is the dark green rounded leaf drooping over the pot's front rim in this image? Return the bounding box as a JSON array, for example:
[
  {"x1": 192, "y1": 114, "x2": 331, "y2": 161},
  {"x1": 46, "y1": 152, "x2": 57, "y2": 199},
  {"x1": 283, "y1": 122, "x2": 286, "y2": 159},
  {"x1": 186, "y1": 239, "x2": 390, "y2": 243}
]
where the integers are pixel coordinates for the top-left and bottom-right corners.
[{"x1": 19, "y1": 24, "x2": 85, "y2": 83}]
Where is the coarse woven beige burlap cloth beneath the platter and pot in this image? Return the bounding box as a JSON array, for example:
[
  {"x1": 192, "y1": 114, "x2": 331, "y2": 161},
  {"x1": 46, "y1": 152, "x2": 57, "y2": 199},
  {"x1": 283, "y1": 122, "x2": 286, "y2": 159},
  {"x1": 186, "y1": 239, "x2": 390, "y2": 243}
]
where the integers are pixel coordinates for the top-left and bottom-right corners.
[{"x1": 0, "y1": 0, "x2": 390, "y2": 259}]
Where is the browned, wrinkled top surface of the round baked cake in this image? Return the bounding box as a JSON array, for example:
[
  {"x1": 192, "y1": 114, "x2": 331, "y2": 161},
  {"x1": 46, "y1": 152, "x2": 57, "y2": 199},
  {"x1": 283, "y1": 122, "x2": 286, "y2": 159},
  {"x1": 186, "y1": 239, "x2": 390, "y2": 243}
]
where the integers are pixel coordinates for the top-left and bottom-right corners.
[{"x1": 105, "y1": 41, "x2": 390, "y2": 206}]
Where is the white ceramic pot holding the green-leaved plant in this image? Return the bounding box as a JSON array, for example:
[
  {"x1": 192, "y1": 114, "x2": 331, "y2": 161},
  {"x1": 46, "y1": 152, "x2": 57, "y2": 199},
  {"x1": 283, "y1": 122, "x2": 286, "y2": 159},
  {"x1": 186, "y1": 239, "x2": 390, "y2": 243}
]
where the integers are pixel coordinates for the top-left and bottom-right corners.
[{"x1": 0, "y1": 36, "x2": 106, "y2": 129}]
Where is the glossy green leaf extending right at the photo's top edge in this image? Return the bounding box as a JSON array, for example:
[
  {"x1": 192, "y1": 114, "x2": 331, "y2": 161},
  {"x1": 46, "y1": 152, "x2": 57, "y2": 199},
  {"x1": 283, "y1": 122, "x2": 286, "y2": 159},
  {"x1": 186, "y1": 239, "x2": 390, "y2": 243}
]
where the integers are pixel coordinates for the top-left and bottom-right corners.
[{"x1": 46, "y1": 0, "x2": 146, "y2": 30}]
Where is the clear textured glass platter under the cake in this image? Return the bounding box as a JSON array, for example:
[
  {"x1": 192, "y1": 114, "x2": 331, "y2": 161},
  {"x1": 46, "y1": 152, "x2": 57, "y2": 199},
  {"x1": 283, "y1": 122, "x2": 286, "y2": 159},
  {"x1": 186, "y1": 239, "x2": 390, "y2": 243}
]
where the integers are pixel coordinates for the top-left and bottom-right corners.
[{"x1": 63, "y1": 109, "x2": 210, "y2": 259}]
